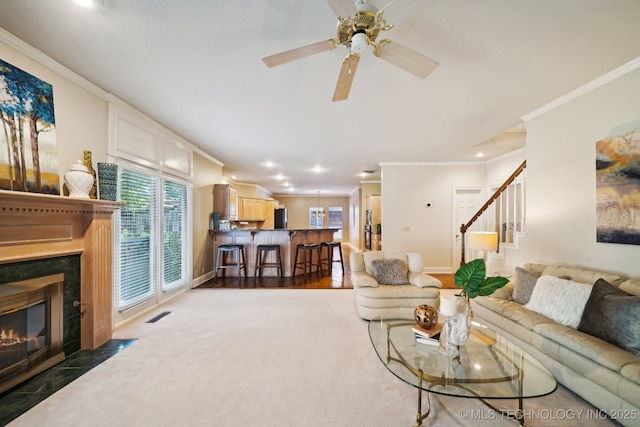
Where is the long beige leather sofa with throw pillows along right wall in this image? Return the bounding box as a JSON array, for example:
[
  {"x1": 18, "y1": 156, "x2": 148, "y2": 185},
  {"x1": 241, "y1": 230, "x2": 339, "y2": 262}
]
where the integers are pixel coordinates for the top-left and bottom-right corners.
[{"x1": 472, "y1": 264, "x2": 640, "y2": 426}]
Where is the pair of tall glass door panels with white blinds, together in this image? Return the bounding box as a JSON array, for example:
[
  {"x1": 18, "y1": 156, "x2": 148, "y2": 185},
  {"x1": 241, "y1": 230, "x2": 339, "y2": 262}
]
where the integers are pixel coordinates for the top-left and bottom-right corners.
[{"x1": 117, "y1": 167, "x2": 189, "y2": 310}]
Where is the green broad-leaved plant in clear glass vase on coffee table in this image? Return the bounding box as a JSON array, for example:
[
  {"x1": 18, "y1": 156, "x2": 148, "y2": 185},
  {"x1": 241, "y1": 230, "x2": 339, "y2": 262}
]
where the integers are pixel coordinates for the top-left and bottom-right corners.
[{"x1": 450, "y1": 258, "x2": 509, "y2": 345}]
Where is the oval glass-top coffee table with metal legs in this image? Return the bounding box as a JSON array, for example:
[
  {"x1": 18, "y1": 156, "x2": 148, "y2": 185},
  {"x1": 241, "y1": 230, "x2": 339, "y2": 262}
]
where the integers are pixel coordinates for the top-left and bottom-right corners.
[{"x1": 369, "y1": 319, "x2": 556, "y2": 426}]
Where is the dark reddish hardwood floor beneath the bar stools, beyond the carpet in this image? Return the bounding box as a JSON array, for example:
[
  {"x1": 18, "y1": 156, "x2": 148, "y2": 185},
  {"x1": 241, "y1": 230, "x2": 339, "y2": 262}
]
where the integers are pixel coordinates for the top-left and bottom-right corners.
[{"x1": 198, "y1": 245, "x2": 455, "y2": 289}]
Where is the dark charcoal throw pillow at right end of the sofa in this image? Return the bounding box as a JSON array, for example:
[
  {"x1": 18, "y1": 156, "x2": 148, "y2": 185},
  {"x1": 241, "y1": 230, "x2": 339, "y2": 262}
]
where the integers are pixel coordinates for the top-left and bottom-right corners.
[{"x1": 578, "y1": 279, "x2": 640, "y2": 355}]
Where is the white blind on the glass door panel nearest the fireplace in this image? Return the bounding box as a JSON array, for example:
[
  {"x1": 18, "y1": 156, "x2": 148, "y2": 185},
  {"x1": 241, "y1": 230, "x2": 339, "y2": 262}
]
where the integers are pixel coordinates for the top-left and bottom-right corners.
[{"x1": 118, "y1": 169, "x2": 157, "y2": 309}]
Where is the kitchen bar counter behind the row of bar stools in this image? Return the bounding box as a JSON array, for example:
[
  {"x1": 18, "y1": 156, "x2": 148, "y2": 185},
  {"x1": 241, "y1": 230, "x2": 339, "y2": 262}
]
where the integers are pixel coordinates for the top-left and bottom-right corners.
[{"x1": 209, "y1": 228, "x2": 339, "y2": 277}]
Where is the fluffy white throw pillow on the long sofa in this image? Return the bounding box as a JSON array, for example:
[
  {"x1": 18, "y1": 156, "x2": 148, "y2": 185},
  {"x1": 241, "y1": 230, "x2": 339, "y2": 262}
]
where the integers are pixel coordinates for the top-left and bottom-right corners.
[{"x1": 525, "y1": 276, "x2": 591, "y2": 329}]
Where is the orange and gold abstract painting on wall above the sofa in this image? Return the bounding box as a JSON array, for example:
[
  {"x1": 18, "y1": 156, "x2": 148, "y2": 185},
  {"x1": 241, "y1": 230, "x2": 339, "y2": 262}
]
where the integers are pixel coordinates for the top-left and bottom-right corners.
[{"x1": 596, "y1": 130, "x2": 640, "y2": 245}]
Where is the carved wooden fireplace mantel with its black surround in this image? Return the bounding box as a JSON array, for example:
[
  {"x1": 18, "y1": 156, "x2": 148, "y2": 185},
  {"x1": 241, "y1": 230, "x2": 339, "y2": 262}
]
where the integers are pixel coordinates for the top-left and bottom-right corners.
[{"x1": 0, "y1": 190, "x2": 122, "y2": 355}]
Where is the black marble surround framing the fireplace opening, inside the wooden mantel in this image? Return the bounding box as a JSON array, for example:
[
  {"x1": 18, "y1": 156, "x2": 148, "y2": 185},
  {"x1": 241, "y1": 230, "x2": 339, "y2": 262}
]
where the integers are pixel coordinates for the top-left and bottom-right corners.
[{"x1": 0, "y1": 255, "x2": 81, "y2": 356}]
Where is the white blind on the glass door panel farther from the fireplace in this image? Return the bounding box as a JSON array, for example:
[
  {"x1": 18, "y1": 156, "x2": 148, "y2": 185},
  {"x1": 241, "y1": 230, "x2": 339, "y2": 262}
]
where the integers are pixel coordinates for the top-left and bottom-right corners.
[{"x1": 162, "y1": 181, "x2": 188, "y2": 290}]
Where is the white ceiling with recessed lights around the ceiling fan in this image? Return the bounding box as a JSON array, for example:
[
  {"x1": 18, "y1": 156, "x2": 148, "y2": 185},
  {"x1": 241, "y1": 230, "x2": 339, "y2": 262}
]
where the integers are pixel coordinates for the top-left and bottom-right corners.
[{"x1": 0, "y1": 0, "x2": 640, "y2": 194}]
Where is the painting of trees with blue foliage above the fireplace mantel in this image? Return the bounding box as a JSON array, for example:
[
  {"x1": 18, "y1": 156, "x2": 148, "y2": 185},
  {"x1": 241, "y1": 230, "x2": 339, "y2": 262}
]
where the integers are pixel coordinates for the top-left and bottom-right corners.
[{"x1": 0, "y1": 60, "x2": 60, "y2": 195}]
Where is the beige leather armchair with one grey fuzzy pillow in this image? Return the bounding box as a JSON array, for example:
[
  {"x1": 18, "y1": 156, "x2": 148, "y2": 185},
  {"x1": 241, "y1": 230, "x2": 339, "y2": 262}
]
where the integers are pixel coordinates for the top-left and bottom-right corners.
[{"x1": 350, "y1": 251, "x2": 442, "y2": 320}]
